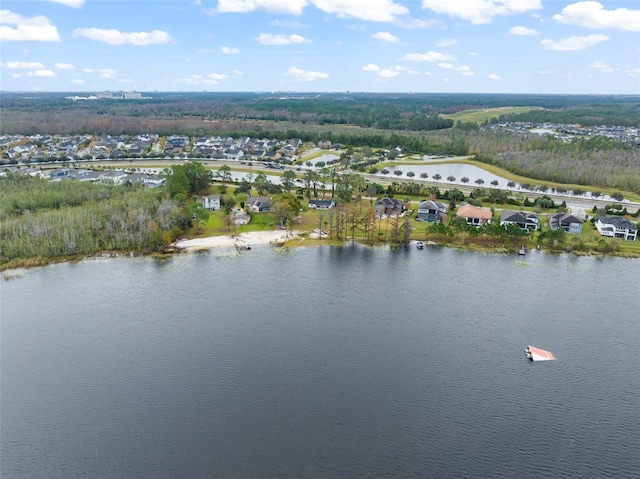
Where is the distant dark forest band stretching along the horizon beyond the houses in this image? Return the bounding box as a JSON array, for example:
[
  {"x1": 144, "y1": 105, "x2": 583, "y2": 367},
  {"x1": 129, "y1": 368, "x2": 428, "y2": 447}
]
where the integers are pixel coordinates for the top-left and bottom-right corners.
[{"x1": 0, "y1": 93, "x2": 640, "y2": 135}]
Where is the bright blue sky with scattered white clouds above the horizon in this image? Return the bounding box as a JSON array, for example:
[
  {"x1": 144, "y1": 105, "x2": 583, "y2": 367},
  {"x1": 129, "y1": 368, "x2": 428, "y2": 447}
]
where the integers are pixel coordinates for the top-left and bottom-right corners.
[{"x1": 0, "y1": 0, "x2": 640, "y2": 94}]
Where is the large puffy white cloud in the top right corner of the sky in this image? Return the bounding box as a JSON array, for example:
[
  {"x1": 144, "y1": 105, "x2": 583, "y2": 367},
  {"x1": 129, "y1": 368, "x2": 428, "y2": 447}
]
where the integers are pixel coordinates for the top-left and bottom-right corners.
[{"x1": 551, "y1": 2, "x2": 640, "y2": 32}]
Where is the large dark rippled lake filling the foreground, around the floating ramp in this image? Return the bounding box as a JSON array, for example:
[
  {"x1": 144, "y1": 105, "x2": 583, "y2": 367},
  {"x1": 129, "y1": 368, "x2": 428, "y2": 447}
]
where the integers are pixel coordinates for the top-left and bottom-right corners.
[{"x1": 0, "y1": 245, "x2": 640, "y2": 479}]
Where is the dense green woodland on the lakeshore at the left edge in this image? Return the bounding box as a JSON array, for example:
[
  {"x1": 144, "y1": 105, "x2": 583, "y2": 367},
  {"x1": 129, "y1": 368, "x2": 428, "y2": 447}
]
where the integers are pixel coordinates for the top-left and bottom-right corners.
[{"x1": 0, "y1": 175, "x2": 186, "y2": 264}]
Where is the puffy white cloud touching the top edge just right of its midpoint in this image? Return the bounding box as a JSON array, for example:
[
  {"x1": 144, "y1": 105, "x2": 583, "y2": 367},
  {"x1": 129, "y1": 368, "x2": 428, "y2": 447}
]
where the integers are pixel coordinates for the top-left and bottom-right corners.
[{"x1": 311, "y1": 0, "x2": 409, "y2": 22}]
